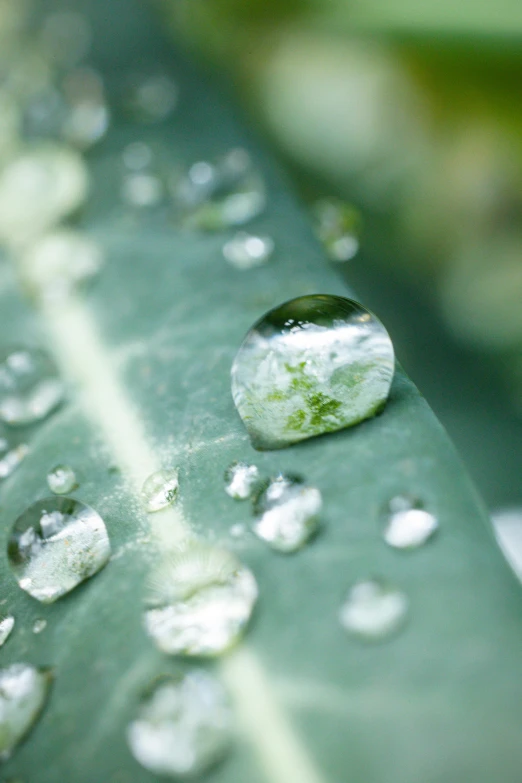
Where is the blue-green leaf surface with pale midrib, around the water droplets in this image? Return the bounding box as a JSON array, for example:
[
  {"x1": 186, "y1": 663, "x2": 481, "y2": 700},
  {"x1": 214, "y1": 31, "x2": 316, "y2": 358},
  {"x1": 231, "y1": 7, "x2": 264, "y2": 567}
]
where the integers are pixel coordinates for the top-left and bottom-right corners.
[{"x1": 0, "y1": 0, "x2": 522, "y2": 783}]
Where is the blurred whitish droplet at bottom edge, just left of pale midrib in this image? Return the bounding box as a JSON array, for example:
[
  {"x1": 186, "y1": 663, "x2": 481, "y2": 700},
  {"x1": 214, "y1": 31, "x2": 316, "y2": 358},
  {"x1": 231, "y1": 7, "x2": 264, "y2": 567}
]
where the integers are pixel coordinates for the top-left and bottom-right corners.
[{"x1": 127, "y1": 669, "x2": 232, "y2": 778}]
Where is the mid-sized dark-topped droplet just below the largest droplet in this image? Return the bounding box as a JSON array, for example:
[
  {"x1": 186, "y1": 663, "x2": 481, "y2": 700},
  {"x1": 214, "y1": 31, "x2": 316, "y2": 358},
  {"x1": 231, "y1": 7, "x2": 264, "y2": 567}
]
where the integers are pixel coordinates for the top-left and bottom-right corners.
[{"x1": 252, "y1": 474, "x2": 322, "y2": 552}]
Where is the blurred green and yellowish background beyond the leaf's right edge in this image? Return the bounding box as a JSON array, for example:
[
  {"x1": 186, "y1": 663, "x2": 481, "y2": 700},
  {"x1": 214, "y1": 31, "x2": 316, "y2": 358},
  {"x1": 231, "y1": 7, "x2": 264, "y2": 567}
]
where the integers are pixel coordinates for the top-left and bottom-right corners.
[{"x1": 158, "y1": 0, "x2": 522, "y2": 510}]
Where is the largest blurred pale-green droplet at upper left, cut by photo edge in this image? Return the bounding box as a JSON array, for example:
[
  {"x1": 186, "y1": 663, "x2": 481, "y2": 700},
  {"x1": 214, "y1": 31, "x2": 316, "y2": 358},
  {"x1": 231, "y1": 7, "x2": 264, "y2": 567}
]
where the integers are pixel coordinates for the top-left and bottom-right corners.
[{"x1": 0, "y1": 145, "x2": 88, "y2": 244}]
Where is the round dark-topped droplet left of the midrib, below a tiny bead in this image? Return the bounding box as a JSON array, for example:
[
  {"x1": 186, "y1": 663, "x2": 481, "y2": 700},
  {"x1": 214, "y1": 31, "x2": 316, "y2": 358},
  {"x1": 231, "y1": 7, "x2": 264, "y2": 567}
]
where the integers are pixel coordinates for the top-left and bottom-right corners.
[{"x1": 7, "y1": 497, "x2": 110, "y2": 603}]
